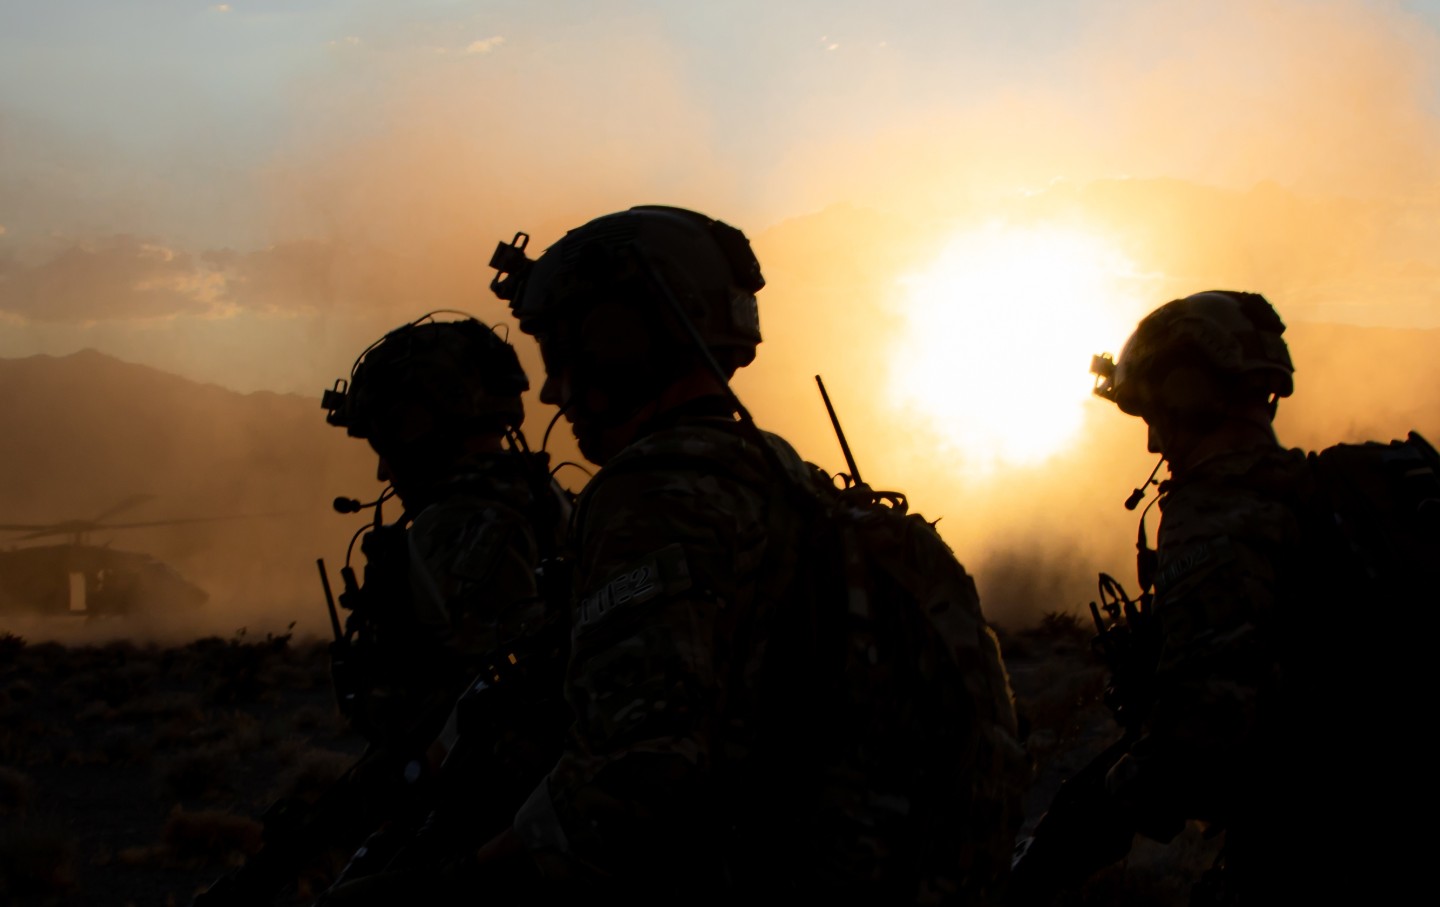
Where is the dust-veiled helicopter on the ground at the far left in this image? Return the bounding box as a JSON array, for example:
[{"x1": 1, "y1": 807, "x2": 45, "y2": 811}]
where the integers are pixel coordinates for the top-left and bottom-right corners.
[{"x1": 0, "y1": 494, "x2": 236, "y2": 618}]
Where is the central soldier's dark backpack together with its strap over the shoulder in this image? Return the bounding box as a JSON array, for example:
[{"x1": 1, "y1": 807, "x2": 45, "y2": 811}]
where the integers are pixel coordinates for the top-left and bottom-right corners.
[{"x1": 567, "y1": 418, "x2": 1028, "y2": 904}]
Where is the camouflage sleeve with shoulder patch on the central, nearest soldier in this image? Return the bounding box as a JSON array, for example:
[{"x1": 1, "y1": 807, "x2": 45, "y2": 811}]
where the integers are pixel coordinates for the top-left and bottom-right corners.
[{"x1": 516, "y1": 457, "x2": 765, "y2": 884}]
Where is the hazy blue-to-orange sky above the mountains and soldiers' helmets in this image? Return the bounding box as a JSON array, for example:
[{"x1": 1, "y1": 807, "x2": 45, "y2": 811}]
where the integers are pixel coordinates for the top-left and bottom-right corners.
[{"x1": 0, "y1": 0, "x2": 1440, "y2": 393}]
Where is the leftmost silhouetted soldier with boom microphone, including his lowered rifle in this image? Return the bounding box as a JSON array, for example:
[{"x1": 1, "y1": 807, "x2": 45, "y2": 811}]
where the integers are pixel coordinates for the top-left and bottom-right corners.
[{"x1": 207, "y1": 315, "x2": 570, "y2": 903}]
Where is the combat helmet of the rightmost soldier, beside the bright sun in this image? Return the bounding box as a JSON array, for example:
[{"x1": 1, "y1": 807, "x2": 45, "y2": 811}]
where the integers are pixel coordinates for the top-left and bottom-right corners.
[{"x1": 1090, "y1": 289, "x2": 1295, "y2": 416}]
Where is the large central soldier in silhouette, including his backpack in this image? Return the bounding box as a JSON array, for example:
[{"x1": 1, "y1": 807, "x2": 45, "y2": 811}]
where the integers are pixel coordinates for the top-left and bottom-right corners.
[{"x1": 437, "y1": 206, "x2": 1020, "y2": 904}]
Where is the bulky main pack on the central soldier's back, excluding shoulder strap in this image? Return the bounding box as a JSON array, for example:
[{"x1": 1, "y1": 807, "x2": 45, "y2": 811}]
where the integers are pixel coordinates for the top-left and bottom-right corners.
[{"x1": 766, "y1": 465, "x2": 1028, "y2": 904}]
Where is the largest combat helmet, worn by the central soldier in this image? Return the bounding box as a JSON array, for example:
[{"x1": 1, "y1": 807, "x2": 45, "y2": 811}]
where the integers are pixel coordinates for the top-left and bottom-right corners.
[{"x1": 491, "y1": 204, "x2": 765, "y2": 369}]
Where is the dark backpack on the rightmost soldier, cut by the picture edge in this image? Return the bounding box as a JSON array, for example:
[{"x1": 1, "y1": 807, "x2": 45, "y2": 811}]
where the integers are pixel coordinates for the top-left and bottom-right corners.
[{"x1": 1306, "y1": 432, "x2": 1440, "y2": 903}]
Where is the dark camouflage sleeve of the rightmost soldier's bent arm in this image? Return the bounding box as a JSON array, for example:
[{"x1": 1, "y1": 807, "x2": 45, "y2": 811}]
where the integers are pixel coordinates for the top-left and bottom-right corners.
[{"x1": 1107, "y1": 487, "x2": 1299, "y2": 829}]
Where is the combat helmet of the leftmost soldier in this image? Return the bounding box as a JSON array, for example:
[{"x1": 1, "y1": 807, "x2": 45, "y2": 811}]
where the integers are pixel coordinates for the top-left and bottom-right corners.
[{"x1": 321, "y1": 312, "x2": 530, "y2": 449}]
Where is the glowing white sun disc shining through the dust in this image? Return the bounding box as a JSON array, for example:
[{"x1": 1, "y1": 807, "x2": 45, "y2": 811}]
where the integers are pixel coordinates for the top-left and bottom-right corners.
[{"x1": 890, "y1": 225, "x2": 1145, "y2": 472}]
